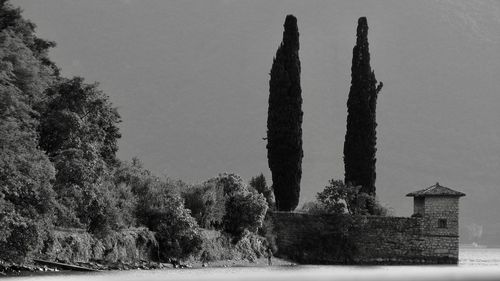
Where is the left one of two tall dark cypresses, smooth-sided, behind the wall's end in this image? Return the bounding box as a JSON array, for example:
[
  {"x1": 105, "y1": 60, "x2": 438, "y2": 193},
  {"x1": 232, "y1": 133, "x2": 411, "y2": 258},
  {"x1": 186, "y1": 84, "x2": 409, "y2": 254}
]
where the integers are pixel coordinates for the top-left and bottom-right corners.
[{"x1": 267, "y1": 15, "x2": 304, "y2": 211}]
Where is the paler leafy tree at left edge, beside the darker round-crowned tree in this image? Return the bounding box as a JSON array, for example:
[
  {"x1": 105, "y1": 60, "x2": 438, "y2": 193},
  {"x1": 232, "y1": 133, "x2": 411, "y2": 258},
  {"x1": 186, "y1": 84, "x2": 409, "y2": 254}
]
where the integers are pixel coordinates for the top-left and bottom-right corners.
[{"x1": 0, "y1": 86, "x2": 54, "y2": 218}]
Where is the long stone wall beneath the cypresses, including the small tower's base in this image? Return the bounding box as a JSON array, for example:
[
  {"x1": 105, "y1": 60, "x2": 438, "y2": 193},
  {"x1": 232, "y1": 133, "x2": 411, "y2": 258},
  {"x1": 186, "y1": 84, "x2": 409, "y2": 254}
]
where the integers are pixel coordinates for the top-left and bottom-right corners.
[{"x1": 267, "y1": 212, "x2": 458, "y2": 264}]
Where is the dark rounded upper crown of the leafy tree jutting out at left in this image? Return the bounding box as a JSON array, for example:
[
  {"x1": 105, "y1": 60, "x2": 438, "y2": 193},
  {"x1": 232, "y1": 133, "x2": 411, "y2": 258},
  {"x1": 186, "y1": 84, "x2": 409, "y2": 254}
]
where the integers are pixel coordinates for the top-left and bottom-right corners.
[{"x1": 40, "y1": 77, "x2": 121, "y2": 166}]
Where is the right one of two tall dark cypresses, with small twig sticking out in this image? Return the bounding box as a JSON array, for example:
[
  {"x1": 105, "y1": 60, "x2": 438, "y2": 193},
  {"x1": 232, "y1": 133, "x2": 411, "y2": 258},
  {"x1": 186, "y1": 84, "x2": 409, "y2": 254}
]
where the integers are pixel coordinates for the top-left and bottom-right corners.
[{"x1": 344, "y1": 17, "x2": 383, "y2": 213}]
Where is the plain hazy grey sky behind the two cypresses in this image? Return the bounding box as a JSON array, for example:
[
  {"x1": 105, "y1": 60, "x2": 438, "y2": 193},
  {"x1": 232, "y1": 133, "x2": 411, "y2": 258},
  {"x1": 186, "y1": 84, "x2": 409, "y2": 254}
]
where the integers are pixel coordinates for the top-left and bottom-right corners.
[{"x1": 12, "y1": 0, "x2": 500, "y2": 241}]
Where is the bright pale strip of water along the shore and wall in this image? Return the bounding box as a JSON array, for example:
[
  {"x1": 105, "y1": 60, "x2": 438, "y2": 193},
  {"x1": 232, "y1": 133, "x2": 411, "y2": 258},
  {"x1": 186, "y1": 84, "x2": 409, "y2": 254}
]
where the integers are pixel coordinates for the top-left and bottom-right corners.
[{"x1": 6, "y1": 249, "x2": 500, "y2": 281}]
